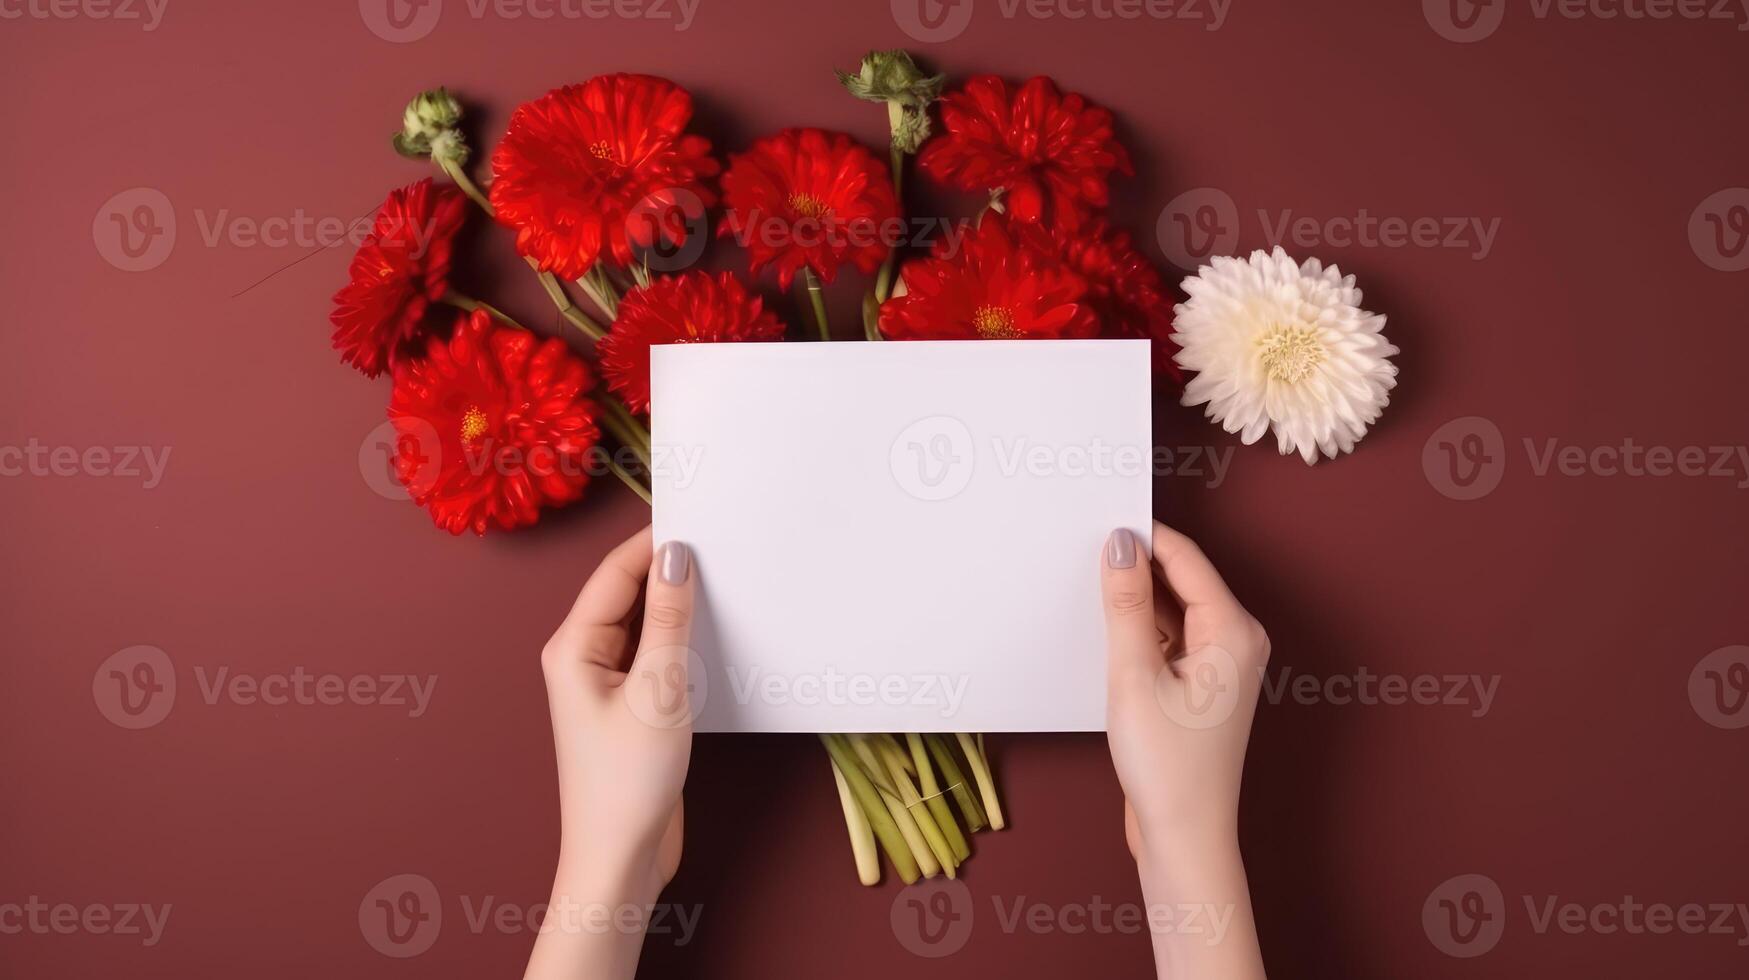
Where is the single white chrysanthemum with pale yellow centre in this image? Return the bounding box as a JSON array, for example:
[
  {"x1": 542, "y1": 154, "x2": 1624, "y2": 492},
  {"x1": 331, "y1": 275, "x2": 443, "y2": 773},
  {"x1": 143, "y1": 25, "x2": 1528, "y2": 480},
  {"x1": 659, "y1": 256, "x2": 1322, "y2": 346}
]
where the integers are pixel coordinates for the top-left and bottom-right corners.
[{"x1": 1172, "y1": 249, "x2": 1397, "y2": 464}]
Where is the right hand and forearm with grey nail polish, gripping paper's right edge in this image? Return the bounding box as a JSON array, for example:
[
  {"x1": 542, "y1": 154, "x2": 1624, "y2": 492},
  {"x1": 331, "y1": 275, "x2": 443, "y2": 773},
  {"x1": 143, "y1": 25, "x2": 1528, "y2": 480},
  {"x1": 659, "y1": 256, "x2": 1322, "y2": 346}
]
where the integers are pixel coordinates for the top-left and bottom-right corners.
[{"x1": 1102, "y1": 523, "x2": 1270, "y2": 980}]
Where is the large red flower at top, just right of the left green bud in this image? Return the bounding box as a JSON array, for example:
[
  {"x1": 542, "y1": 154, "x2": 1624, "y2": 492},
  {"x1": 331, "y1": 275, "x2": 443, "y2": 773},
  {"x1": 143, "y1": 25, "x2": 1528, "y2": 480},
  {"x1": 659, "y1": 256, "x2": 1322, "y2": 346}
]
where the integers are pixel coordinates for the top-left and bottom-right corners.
[{"x1": 491, "y1": 75, "x2": 721, "y2": 278}]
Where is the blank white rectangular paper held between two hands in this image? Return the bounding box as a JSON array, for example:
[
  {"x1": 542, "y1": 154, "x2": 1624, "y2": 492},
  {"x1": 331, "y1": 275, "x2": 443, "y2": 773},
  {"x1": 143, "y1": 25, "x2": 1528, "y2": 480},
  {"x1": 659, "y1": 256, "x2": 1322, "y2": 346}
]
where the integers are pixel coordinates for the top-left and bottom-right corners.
[{"x1": 651, "y1": 340, "x2": 1153, "y2": 732}]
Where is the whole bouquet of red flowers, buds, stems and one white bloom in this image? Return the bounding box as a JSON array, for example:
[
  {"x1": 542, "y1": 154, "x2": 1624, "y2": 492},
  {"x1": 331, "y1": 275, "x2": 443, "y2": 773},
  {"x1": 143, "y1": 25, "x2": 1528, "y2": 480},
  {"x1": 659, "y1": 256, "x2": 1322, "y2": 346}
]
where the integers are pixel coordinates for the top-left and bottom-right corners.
[{"x1": 331, "y1": 51, "x2": 1394, "y2": 884}]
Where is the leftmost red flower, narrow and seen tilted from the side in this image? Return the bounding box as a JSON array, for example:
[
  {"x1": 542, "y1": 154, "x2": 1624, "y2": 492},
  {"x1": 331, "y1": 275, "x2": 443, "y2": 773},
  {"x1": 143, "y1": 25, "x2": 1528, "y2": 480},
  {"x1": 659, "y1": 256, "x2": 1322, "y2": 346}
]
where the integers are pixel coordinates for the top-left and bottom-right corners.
[{"x1": 329, "y1": 179, "x2": 467, "y2": 378}]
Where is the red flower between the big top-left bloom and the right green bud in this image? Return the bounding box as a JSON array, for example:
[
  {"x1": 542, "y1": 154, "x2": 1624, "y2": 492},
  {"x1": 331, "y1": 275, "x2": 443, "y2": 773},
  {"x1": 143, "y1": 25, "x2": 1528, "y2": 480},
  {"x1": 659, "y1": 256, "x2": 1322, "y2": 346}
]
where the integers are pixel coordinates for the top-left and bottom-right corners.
[{"x1": 717, "y1": 130, "x2": 899, "y2": 289}]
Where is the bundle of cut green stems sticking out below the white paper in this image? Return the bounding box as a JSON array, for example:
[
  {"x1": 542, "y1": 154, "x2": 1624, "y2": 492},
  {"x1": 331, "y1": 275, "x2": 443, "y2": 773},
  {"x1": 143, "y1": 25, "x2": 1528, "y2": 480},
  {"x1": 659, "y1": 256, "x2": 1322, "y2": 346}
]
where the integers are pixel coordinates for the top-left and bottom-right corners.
[{"x1": 820, "y1": 733, "x2": 1006, "y2": 886}]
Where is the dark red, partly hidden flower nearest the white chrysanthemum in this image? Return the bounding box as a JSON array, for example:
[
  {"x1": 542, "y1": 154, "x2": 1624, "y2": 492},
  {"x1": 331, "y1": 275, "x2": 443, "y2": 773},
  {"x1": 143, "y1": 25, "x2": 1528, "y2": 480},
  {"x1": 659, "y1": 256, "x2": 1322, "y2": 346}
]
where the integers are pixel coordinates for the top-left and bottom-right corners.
[{"x1": 1053, "y1": 219, "x2": 1184, "y2": 385}]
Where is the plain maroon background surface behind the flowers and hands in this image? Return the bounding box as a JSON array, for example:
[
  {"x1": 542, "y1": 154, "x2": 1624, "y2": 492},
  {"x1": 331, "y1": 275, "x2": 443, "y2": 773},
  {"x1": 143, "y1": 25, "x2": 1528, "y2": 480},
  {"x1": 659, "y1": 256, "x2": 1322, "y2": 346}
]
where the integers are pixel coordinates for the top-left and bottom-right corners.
[{"x1": 0, "y1": 0, "x2": 1749, "y2": 980}]
